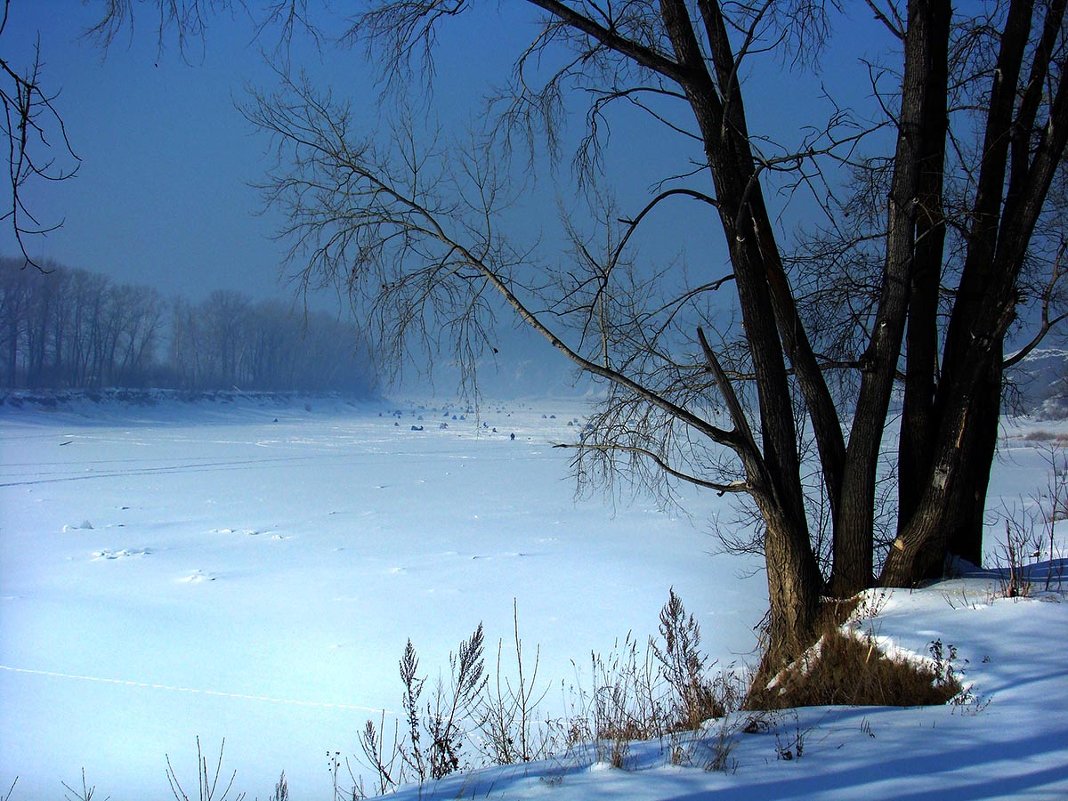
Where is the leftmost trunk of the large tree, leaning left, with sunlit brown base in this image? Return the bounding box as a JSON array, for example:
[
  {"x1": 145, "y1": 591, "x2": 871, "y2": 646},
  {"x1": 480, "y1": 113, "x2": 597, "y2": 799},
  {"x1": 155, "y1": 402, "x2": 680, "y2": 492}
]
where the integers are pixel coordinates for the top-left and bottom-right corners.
[{"x1": 661, "y1": 0, "x2": 822, "y2": 665}]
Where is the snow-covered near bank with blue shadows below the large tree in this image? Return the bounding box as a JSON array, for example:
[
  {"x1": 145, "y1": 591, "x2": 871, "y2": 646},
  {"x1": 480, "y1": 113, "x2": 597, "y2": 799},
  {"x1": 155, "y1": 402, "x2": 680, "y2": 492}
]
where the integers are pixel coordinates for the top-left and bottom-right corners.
[{"x1": 373, "y1": 579, "x2": 1068, "y2": 801}]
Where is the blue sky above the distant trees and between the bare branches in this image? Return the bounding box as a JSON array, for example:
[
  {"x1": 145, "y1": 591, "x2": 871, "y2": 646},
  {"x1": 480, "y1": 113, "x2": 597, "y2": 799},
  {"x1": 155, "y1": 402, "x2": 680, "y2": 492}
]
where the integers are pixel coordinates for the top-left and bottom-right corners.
[{"x1": 0, "y1": 0, "x2": 889, "y2": 401}]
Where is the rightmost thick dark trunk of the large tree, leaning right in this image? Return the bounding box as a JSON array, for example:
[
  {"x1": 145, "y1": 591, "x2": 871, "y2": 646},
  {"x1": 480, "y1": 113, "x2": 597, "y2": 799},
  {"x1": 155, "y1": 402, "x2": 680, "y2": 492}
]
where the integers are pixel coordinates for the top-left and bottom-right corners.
[{"x1": 881, "y1": 0, "x2": 1068, "y2": 585}]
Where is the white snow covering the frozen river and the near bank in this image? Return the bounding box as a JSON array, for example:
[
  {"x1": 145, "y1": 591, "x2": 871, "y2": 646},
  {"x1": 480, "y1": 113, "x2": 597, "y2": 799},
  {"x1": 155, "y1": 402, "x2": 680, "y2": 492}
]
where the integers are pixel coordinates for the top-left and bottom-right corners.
[{"x1": 0, "y1": 398, "x2": 1068, "y2": 801}]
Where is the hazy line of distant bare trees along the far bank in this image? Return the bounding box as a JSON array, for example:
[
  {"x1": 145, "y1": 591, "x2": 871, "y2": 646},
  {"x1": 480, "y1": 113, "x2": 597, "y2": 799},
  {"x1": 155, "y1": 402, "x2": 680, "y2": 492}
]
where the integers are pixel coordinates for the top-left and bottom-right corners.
[{"x1": 0, "y1": 258, "x2": 375, "y2": 394}]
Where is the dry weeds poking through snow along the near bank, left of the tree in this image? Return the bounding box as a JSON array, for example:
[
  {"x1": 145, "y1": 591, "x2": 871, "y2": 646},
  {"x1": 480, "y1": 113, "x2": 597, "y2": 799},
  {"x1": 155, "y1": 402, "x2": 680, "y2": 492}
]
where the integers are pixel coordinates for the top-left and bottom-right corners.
[{"x1": 348, "y1": 590, "x2": 743, "y2": 798}]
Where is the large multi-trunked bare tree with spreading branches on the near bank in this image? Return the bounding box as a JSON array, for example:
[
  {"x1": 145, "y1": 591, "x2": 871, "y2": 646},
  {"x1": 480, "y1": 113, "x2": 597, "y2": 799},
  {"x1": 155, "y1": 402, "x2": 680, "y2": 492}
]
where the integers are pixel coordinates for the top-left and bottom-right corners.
[{"x1": 247, "y1": 0, "x2": 1068, "y2": 679}]
